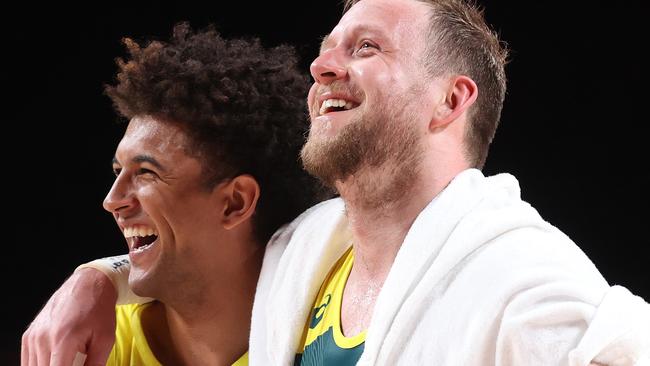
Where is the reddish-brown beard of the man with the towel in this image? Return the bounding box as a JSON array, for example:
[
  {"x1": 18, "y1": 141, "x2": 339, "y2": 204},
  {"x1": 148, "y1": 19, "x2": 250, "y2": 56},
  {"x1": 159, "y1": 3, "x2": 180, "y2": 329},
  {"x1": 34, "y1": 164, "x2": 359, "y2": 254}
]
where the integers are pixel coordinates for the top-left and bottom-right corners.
[{"x1": 300, "y1": 94, "x2": 423, "y2": 208}]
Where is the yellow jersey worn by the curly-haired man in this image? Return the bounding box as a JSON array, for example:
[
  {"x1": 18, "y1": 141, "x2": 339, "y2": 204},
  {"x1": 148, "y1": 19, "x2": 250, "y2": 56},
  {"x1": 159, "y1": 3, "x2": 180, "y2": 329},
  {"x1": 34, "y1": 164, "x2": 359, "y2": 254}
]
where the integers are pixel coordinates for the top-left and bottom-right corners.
[{"x1": 106, "y1": 303, "x2": 248, "y2": 366}]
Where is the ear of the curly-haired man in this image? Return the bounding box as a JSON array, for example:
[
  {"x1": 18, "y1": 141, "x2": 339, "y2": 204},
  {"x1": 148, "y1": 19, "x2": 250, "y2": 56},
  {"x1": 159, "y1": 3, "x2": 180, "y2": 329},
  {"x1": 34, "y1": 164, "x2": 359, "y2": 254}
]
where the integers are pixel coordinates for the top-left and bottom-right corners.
[{"x1": 221, "y1": 174, "x2": 260, "y2": 230}]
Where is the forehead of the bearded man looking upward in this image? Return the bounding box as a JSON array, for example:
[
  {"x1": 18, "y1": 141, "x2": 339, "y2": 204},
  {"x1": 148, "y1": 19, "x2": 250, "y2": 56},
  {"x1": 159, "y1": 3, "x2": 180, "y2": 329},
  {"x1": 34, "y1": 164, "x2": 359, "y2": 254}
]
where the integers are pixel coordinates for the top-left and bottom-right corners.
[{"x1": 323, "y1": 0, "x2": 430, "y2": 48}]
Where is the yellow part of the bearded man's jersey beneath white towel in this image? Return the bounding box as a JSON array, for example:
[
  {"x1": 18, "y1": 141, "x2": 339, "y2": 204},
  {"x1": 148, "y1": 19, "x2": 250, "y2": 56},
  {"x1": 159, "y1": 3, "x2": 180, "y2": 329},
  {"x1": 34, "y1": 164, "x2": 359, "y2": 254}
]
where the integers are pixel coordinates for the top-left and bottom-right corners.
[{"x1": 298, "y1": 247, "x2": 366, "y2": 353}]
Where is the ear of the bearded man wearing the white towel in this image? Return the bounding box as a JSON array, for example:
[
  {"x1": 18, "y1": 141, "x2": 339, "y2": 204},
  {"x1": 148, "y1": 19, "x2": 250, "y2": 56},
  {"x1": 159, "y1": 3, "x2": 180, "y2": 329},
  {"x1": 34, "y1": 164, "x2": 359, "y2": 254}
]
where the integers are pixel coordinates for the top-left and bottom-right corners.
[{"x1": 429, "y1": 75, "x2": 478, "y2": 130}]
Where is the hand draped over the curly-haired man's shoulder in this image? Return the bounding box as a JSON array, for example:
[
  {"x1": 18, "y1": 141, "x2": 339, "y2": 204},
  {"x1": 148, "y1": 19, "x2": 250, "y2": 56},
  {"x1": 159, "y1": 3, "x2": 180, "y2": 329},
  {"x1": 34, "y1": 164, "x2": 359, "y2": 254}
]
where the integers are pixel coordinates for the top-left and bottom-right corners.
[{"x1": 21, "y1": 268, "x2": 117, "y2": 366}]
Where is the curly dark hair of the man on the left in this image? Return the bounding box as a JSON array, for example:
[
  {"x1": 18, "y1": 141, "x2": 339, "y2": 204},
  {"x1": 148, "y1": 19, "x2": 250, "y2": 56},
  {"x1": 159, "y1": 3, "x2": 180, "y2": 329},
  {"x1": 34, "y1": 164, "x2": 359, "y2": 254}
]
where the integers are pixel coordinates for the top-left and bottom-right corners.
[{"x1": 105, "y1": 23, "x2": 331, "y2": 244}]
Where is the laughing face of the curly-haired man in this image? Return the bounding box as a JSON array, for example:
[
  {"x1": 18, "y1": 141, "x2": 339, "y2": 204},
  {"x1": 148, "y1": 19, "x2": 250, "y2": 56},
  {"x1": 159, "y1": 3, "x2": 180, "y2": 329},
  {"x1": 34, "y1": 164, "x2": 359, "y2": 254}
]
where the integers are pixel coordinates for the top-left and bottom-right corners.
[{"x1": 104, "y1": 117, "x2": 228, "y2": 298}]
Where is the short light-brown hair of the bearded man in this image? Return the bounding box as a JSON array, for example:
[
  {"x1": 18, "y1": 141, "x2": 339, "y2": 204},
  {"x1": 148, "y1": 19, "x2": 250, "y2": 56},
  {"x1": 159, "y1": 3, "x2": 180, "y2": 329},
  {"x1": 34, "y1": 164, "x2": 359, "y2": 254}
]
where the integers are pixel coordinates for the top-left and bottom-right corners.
[{"x1": 343, "y1": 0, "x2": 508, "y2": 169}]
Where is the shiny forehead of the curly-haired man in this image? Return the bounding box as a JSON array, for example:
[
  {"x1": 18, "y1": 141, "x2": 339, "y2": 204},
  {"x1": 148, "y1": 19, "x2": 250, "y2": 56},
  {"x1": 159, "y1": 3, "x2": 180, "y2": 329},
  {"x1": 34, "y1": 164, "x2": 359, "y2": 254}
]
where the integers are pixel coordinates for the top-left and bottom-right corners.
[{"x1": 118, "y1": 116, "x2": 188, "y2": 156}]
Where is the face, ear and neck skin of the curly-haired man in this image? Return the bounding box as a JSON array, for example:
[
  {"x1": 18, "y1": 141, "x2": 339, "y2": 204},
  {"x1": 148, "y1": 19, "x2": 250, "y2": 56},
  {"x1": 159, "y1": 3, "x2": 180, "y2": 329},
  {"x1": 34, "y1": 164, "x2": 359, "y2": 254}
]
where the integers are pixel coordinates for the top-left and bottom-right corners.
[{"x1": 104, "y1": 116, "x2": 264, "y2": 365}]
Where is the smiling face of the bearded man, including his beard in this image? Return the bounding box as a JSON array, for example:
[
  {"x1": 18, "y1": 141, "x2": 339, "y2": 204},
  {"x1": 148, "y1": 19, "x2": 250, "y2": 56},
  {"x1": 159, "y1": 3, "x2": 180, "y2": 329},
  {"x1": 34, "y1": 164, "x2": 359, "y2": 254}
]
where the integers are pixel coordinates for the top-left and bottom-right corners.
[{"x1": 301, "y1": 0, "x2": 434, "y2": 189}]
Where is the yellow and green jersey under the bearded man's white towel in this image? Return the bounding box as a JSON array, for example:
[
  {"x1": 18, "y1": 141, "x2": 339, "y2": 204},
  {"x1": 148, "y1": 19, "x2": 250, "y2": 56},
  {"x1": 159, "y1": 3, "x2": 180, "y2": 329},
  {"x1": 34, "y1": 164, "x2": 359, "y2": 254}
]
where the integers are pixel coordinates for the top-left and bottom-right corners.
[{"x1": 294, "y1": 247, "x2": 366, "y2": 366}]
